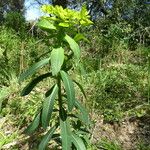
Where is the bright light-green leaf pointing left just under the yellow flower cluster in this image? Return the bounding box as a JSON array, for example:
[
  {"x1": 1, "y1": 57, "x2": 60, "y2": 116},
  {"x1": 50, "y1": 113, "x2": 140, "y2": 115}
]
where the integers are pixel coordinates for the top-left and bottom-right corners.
[{"x1": 37, "y1": 19, "x2": 57, "y2": 30}]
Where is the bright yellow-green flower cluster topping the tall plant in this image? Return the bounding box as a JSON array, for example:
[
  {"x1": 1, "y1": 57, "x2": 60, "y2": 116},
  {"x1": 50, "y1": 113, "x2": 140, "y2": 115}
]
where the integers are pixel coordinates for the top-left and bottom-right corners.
[{"x1": 41, "y1": 5, "x2": 93, "y2": 27}]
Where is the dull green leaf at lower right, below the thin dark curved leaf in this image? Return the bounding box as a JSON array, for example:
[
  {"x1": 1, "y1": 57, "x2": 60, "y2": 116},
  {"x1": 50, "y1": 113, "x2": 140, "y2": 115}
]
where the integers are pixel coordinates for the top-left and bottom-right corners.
[{"x1": 75, "y1": 100, "x2": 90, "y2": 125}]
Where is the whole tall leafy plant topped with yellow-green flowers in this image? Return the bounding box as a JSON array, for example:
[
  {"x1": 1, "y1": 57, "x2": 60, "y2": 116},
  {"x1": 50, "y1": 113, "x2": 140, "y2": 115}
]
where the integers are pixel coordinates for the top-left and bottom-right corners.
[{"x1": 19, "y1": 5, "x2": 92, "y2": 150}]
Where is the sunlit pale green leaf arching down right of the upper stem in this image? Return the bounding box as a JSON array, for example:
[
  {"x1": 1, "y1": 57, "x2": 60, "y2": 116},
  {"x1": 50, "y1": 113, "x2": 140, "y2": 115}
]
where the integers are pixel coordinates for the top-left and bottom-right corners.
[{"x1": 65, "y1": 35, "x2": 81, "y2": 59}]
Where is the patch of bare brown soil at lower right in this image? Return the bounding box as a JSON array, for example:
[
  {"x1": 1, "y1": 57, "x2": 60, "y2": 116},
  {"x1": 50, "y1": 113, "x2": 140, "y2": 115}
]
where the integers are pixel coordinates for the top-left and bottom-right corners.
[{"x1": 92, "y1": 115, "x2": 150, "y2": 150}]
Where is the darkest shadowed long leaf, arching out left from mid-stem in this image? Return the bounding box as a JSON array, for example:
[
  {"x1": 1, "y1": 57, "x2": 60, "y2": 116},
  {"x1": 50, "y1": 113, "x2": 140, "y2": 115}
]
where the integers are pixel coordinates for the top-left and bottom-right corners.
[{"x1": 21, "y1": 73, "x2": 52, "y2": 96}]
